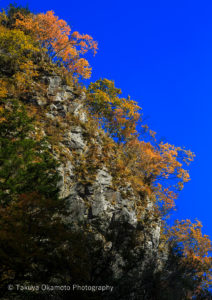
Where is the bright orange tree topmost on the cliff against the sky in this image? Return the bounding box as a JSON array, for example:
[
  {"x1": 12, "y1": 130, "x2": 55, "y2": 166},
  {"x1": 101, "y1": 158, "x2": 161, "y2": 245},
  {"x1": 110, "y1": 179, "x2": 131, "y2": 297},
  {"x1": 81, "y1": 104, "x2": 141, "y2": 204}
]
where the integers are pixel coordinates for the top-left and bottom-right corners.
[{"x1": 15, "y1": 11, "x2": 97, "y2": 78}]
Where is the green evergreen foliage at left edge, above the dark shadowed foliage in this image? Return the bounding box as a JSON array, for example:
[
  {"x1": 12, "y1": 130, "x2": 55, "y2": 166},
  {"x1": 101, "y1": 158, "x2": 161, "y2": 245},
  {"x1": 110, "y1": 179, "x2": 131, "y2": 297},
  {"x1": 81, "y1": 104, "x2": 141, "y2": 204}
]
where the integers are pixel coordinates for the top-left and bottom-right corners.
[{"x1": 0, "y1": 100, "x2": 58, "y2": 204}]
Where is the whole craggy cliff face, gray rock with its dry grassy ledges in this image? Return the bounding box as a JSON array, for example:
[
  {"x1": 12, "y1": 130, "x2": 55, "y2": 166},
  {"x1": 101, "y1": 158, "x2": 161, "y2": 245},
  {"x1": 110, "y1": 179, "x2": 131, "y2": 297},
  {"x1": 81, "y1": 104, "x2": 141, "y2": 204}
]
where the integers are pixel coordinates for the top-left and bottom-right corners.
[{"x1": 31, "y1": 75, "x2": 160, "y2": 299}]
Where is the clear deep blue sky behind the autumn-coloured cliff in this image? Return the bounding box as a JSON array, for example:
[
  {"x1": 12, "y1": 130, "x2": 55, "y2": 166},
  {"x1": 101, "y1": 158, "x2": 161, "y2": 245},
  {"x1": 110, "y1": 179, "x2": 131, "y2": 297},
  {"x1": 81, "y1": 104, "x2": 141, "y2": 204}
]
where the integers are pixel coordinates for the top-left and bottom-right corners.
[{"x1": 0, "y1": 0, "x2": 212, "y2": 237}]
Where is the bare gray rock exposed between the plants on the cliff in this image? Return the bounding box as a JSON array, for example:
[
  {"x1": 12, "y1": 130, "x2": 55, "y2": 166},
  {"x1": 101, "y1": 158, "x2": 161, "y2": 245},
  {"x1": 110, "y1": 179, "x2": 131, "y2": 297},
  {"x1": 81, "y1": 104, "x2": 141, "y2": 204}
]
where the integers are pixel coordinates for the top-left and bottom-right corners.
[{"x1": 38, "y1": 76, "x2": 160, "y2": 300}]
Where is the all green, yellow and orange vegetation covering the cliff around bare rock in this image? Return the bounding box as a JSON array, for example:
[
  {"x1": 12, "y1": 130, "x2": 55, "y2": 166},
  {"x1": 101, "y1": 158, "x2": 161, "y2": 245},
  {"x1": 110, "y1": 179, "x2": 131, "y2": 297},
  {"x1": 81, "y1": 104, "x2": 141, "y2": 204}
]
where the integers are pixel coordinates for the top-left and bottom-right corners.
[{"x1": 0, "y1": 5, "x2": 212, "y2": 300}]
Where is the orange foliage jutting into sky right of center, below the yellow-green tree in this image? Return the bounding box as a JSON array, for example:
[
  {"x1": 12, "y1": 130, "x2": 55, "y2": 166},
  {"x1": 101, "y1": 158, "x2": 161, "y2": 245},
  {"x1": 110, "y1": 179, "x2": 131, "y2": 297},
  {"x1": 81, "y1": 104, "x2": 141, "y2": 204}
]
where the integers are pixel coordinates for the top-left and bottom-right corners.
[{"x1": 123, "y1": 138, "x2": 194, "y2": 212}]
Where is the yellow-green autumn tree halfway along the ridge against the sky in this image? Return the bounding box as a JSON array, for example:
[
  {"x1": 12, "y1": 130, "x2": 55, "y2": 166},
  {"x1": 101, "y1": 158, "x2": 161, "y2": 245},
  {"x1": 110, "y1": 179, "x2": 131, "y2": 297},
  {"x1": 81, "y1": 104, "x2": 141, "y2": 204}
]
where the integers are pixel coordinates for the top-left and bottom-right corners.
[{"x1": 87, "y1": 79, "x2": 141, "y2": 143}]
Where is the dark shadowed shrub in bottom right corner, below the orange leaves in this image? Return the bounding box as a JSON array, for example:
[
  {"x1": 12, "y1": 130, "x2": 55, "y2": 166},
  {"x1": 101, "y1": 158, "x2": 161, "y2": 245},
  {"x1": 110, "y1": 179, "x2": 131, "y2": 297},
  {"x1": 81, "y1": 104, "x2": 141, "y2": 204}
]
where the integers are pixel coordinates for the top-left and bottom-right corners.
[{"x1": 146, "y1": 242, "x2": 212, "y2": 300}]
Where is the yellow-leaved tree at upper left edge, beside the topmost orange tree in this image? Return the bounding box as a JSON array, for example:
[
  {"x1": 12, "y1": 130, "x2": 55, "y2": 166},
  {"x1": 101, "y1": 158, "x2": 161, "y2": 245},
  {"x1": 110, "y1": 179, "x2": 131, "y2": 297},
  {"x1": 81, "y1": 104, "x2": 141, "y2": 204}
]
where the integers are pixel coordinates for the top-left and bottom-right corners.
[{"x1": 0, "y1": 13, "x2": 41, "y2": 97}]
